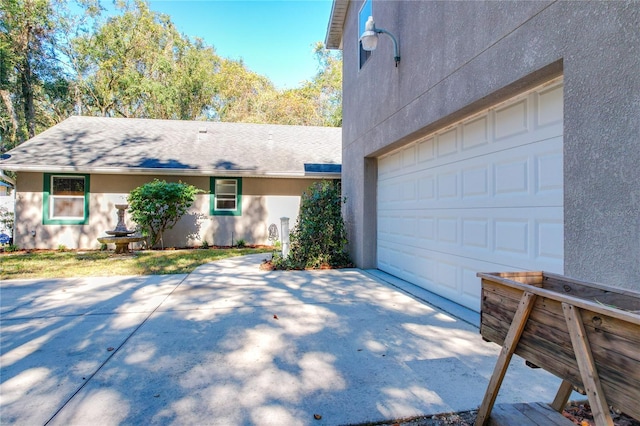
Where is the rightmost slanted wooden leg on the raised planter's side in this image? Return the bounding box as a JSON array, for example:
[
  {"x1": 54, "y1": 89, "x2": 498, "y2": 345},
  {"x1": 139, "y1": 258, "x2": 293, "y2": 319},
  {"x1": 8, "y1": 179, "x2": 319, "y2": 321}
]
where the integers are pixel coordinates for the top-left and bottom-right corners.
[{"x1": 562, "y1": 303, "x2": 613, "y2": 426}]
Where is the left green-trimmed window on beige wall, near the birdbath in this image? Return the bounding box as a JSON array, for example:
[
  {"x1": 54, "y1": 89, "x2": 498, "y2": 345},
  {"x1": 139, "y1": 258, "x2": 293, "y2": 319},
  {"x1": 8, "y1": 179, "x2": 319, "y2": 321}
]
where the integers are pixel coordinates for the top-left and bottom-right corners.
[{"x1": 42, "y1": 173, "x2": 89, "y2": 225}]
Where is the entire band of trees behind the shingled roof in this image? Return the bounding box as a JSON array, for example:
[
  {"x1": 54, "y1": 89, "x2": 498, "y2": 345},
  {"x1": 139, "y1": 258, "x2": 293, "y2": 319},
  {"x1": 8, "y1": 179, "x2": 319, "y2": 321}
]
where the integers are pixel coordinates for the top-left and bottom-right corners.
[{"x1": 0, "y1": 0, "x2": 342, "y2": 152}]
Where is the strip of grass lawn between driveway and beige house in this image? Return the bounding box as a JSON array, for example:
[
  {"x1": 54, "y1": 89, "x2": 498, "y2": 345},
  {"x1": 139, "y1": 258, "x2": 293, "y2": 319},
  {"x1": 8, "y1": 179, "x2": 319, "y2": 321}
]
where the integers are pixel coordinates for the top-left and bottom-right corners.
[{"x1": 0, "y1": 248, "x2": 273, "y2": 280}]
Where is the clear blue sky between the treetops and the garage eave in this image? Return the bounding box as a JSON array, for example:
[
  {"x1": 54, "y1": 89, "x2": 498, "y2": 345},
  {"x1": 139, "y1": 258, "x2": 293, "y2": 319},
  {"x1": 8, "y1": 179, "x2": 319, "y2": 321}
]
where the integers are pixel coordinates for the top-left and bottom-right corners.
[{"x1": 149, "y1": 0, "x2": 332, "y2": 89}]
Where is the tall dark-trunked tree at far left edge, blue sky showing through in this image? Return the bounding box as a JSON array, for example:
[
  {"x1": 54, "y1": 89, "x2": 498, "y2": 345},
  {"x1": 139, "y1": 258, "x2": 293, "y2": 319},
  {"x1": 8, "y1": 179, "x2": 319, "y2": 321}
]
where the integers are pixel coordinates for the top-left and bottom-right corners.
[{"x1": 0, "y1": 0, "x2": 99, "y2": 150}]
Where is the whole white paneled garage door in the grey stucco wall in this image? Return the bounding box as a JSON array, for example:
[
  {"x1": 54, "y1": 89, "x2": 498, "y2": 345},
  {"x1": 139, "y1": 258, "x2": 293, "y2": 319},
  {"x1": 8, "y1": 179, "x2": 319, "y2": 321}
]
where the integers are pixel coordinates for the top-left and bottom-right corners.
[{"x1": 377, "y1": 80, "x2": 564, "y2": 311}]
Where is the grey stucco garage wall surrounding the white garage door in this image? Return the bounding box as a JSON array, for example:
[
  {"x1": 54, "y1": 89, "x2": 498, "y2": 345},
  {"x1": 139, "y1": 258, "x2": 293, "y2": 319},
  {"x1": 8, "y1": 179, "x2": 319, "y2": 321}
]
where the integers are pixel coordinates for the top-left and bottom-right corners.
[{"x1": 342, "y1": 0, "x2": 640, "y2": 288}]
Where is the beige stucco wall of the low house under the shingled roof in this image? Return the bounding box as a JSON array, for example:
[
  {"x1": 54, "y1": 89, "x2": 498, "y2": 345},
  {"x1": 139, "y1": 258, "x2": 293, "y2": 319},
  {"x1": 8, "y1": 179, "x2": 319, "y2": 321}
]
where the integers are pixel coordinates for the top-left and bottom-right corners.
[{"x1": 15, "y1": 173, "x2": 336, "y2": 249}]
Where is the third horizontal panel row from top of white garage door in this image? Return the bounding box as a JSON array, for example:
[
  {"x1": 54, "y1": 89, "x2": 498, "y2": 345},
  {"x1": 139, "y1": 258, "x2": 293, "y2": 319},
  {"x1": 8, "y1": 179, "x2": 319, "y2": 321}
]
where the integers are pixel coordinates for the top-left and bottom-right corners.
[{"x1": 378, "y1": 207, "x2": 564, "y2": 272}]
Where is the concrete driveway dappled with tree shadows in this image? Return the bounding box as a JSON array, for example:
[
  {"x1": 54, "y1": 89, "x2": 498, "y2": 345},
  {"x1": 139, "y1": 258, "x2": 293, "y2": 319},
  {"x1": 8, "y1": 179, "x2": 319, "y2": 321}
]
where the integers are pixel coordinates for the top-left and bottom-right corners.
[{"x1": 0, "y1": 255, "x2": 560, "y2": 425}]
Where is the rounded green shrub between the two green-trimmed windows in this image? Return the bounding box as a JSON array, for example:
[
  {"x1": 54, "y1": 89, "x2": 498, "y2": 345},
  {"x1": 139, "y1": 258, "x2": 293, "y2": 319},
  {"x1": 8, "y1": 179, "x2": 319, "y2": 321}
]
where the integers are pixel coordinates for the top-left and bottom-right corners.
[{"x1": 127, "y1": 179, "x2": 202, "y2": 247}]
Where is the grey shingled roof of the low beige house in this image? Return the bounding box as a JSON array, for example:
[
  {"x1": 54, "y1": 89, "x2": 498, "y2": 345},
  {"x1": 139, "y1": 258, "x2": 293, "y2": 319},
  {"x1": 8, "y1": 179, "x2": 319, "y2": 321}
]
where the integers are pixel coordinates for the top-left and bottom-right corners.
[{"x1": 0, "y1": 116, "x2": 342, "y2": 178}]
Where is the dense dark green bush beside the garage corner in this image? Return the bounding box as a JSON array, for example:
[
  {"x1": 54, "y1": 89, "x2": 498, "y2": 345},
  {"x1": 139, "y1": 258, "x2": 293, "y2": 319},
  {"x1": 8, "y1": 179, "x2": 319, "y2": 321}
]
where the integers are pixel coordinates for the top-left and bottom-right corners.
[{"x1": 273, "y1": 181, "x2": 351, "y2": 269}]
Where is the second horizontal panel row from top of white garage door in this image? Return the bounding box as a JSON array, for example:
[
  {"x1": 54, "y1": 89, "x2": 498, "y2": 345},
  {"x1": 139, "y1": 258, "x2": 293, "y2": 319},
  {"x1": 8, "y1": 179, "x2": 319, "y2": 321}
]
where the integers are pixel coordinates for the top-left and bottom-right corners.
[{"x1": 378, "y1": 137, "x2": 563, "y2": 210}]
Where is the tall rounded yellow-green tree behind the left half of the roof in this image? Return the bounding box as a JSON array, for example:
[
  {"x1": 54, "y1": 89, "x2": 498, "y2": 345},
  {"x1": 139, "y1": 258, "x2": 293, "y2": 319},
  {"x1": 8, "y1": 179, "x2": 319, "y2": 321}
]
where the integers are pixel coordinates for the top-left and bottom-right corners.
[{"x1": 70, "y1": 0, "x2": 220, "y2": 120}]
